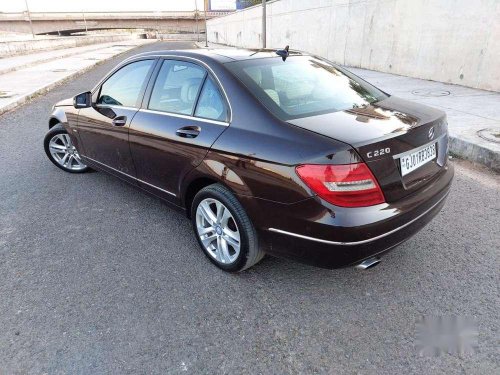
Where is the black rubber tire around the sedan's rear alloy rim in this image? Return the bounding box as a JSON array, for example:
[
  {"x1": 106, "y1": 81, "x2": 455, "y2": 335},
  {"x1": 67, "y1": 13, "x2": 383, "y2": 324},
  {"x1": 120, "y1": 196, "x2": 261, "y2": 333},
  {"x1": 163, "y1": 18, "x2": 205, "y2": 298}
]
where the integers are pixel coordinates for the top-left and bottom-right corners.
[{"x1": 191, "y1": 184, "x2": 265, "y2": 272}]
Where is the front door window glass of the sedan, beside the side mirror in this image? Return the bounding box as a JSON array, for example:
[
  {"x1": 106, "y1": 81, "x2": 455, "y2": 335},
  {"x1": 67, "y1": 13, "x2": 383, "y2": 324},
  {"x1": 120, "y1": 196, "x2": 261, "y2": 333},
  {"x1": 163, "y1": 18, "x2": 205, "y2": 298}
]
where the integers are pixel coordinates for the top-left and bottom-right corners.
[{"x1": 97, "y1": 60, "x2": 154, "y2": 107}]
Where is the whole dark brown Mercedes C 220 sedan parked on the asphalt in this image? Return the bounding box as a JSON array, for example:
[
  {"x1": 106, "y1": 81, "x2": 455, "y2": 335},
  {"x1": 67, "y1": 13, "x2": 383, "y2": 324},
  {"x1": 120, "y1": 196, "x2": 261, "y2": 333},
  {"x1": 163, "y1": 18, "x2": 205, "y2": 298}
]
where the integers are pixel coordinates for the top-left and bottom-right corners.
[{"x1": 44, "y1": 49, "x2": 453, "y2": 271}]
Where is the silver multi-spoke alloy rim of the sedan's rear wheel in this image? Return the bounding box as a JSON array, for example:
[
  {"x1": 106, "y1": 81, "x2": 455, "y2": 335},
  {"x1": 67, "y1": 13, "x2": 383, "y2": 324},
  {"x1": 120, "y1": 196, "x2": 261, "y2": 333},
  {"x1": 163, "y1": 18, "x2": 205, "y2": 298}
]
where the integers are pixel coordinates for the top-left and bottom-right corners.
[{"x1": 196, "y1": 198, "x2": 241, "y2": 265}]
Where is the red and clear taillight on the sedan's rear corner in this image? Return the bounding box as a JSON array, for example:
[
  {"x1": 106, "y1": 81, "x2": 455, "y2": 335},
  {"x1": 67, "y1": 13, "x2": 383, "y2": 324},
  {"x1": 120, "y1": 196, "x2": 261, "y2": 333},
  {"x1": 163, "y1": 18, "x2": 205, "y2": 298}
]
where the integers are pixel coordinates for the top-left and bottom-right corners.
[{"x1": 295, "y1": 163, "x2": 385, "y2": 207}]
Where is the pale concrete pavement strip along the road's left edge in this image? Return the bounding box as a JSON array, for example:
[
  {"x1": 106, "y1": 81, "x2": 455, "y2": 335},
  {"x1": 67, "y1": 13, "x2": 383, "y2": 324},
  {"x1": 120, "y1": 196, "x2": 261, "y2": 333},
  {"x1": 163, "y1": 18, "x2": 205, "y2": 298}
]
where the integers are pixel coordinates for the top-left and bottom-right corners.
[{"x1": 0, "y1": 39, "x2": 155, "y2": 114}]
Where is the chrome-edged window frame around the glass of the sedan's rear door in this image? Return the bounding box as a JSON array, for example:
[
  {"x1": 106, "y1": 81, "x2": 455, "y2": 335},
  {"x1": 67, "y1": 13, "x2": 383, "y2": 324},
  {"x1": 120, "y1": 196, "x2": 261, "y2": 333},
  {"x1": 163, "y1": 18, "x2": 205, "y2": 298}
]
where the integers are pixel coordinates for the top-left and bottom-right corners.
[{"x1": 140, "y1": 55, "x2": 233, "y2": 126}]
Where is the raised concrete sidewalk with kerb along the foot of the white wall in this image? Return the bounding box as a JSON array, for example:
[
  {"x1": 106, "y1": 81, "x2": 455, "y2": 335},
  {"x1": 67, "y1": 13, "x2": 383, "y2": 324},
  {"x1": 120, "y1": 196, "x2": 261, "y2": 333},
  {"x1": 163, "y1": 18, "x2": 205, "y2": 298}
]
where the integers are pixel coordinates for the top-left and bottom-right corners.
[{"x1": 196, "y1": 41, "x2": 500, "y2": 172}]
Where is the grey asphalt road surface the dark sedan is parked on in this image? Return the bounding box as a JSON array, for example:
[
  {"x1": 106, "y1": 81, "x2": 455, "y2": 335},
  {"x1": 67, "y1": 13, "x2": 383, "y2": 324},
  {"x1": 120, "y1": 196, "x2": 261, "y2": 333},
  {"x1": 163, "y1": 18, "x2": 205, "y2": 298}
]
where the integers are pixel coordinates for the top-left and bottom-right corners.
[{"x1": 0, "y1": 43, "x2": 500, "y2": 374}]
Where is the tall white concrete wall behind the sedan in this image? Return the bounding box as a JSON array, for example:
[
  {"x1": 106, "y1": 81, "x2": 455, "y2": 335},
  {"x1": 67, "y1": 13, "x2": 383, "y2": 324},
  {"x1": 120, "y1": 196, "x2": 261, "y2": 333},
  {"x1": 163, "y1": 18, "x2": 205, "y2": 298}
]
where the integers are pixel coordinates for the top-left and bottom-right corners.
[{"x1": 208, "y1": 0, "x2": 500, "y2": 91}]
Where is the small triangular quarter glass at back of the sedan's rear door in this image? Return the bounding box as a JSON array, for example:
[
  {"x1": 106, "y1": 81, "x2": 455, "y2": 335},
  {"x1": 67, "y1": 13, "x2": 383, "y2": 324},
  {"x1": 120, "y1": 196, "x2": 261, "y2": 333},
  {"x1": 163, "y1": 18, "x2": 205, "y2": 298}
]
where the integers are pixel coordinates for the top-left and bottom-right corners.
[{"x1": 194, "y1": 77, "x2": 227, "y2": 121}]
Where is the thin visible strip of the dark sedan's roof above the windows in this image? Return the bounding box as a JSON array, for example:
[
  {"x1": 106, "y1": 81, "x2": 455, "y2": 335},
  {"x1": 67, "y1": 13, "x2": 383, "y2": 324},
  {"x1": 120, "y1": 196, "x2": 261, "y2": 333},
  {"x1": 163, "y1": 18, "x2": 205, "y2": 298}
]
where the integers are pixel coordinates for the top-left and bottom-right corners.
[{"x1": 131, "y1": 48, "x2": 305, "y2": 64}]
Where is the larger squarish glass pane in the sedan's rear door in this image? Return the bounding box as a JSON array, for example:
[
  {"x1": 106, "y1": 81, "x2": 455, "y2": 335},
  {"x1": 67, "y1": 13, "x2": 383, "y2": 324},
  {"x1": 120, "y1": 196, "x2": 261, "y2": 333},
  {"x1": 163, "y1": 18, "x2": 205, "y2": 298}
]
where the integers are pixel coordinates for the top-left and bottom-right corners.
[{"x1": 148, "y1": 60, "x2": 206, "y2": 115}]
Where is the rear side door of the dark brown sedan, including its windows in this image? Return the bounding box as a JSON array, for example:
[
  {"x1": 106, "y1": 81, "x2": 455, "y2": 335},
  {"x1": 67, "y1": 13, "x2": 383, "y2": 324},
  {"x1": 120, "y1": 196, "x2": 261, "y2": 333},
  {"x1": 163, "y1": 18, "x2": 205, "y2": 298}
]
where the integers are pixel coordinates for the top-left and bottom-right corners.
[{"x1": 129, "y1": 59, "x2": 230, "y2": 203}]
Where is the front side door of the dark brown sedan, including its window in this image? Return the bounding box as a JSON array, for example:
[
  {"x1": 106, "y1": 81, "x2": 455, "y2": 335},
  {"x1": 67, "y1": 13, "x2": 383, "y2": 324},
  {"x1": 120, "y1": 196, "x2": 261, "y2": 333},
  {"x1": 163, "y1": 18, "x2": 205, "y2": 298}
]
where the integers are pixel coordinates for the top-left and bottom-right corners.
[{"x1": 77, "y1": 59, "x2": 155, "y2": 182}]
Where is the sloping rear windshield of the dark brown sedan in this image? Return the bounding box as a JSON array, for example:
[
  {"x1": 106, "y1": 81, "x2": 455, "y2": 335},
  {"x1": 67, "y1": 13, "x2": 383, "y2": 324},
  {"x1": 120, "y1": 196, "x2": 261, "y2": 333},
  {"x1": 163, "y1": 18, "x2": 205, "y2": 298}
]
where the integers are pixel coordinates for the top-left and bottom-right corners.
[{"x1": 226, "y1": 56, "x2": 387, "y2": 121}]
